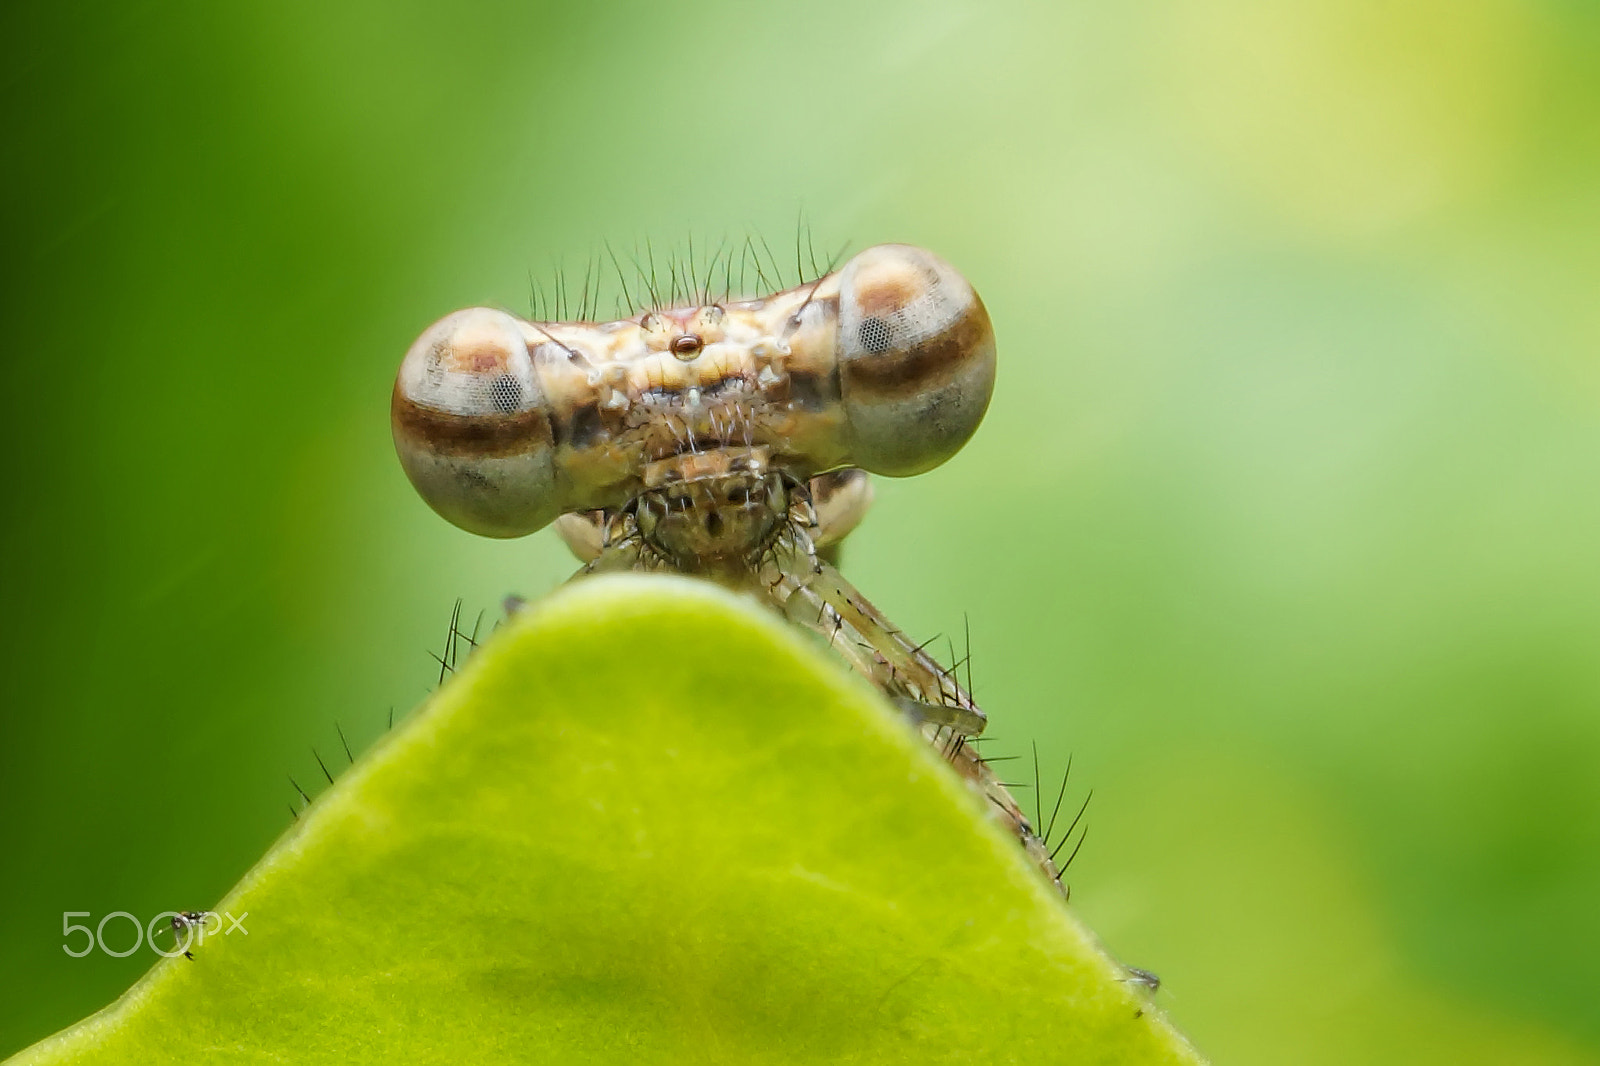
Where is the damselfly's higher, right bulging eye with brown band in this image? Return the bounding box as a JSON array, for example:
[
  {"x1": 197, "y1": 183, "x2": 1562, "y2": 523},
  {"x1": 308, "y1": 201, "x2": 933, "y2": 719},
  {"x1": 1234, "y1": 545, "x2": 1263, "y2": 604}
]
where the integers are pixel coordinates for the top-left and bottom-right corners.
[{"x1": 838, "y1": 245, "x2": 995, "y2": 477}]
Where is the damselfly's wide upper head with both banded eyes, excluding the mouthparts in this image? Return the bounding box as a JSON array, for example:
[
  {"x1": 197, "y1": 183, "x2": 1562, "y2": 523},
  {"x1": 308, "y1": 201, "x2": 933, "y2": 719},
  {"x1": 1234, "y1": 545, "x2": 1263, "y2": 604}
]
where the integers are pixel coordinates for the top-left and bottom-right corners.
[{"x1": 392, "y1": 245, "x2": 995, "y2": 536}]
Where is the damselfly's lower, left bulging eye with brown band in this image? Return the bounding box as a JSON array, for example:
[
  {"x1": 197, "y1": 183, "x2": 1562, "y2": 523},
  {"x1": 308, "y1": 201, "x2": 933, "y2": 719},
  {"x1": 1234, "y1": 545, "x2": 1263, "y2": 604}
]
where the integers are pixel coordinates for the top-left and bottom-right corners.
[{"x1": 390, "y1": 307, "x2": 562, "y2": 536}]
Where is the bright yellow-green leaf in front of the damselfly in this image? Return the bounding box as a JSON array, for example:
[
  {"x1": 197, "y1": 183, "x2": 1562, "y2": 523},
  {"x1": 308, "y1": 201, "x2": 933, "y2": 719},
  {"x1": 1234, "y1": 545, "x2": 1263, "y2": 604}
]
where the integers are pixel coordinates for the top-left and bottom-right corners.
[{"x1": 14, "y1": 575, "x2": 1198, "y2": 1064}]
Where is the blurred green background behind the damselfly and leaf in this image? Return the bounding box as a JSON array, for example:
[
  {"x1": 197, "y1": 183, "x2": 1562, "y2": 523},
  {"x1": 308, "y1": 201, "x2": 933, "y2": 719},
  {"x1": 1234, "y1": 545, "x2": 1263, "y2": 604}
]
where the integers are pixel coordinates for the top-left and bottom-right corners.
[{"x1": 0, "y1": 0, "x2": 1600, "y2": 1063}]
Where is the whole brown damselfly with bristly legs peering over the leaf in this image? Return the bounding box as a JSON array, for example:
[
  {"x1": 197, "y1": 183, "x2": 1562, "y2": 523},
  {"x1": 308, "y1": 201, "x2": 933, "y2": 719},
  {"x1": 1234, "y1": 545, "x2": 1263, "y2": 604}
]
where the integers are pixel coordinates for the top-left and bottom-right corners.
[{"x1": 392, "y1": 245, "x2": 1059, "y2": 888}]
